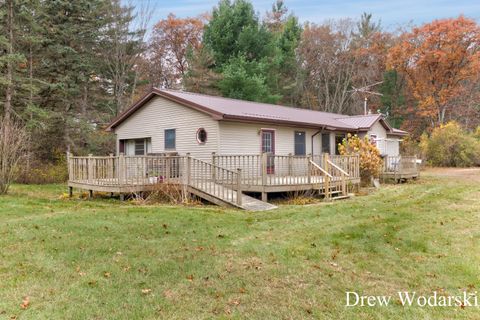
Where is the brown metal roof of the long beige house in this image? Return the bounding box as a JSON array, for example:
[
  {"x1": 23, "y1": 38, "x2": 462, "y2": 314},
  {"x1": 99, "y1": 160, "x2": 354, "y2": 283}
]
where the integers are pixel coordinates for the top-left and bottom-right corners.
[{"x1": 107, "y1": 89, "x2": 408, "y2": 136}]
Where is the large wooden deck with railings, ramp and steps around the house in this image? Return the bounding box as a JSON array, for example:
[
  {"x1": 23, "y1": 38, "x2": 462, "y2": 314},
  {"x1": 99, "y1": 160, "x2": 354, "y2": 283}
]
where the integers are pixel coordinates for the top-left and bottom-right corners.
[{"x1": 68, "y1": 154, "x2": 360, "y2": 210}]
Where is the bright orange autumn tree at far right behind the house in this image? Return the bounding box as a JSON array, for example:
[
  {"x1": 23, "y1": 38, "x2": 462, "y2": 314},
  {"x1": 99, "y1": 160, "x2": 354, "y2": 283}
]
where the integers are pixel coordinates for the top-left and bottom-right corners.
[{"x1": 388, "y1": 16, "x2": 480, "y2": 127}]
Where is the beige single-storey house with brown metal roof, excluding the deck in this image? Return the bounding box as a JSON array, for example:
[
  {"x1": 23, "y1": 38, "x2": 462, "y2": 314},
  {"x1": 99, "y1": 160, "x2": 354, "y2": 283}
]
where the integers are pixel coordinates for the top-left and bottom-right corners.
[{"x1": 107, "y1": 89, "x2": 407, "y2": 161}]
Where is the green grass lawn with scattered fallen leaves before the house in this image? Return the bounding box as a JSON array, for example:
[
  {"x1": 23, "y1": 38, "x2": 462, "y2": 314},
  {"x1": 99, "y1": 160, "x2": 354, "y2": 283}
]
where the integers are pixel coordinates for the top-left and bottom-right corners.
[{"x1": 0, "y1": 171, "x2": 480, "y2": 319}]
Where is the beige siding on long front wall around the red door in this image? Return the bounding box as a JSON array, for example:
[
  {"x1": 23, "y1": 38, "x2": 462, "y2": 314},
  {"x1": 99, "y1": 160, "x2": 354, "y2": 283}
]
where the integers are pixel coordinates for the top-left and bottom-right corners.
[{"x1": 219, "y1": 121, "x2": 321, "y2": 155}]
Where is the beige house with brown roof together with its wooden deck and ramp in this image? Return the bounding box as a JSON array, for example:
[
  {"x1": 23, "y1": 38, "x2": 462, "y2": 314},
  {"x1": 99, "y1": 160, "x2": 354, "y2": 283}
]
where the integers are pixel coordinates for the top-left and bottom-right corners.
[{"x1": 67, "y1": 89, "x2": 415, "y2": 210}]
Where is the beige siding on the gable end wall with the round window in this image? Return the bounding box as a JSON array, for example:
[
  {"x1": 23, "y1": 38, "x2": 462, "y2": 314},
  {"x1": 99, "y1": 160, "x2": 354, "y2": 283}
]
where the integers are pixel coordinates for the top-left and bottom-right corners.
[{"x1": 115, "y1": 97, "x2": 219, "y2": 160}]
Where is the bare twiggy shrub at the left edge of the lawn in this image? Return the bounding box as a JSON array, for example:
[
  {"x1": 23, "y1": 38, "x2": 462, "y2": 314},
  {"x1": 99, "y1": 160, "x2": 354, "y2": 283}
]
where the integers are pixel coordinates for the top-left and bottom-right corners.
[{"x1": 0, "y1": 117, "x2": 29, "y2": 194}]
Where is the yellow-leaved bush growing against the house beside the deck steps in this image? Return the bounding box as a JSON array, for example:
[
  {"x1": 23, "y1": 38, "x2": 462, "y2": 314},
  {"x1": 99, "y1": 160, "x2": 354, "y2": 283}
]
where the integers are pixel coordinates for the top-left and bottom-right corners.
[{"x1": 338, "y1": 134, "x2": 383, "y2": 185}]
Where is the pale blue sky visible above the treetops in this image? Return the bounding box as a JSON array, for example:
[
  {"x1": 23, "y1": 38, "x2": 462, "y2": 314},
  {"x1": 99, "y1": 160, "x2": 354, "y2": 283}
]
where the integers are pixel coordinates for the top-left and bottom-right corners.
[{"x1": 129, "y1": 0, "x2": 480, "y2": 30}]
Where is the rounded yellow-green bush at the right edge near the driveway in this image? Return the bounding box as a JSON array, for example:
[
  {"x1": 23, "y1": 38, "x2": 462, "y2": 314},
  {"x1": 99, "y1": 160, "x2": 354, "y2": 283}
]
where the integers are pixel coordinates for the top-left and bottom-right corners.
[{"x1": 420, "y1": 122, "x2": 480, "y2": 167}]
